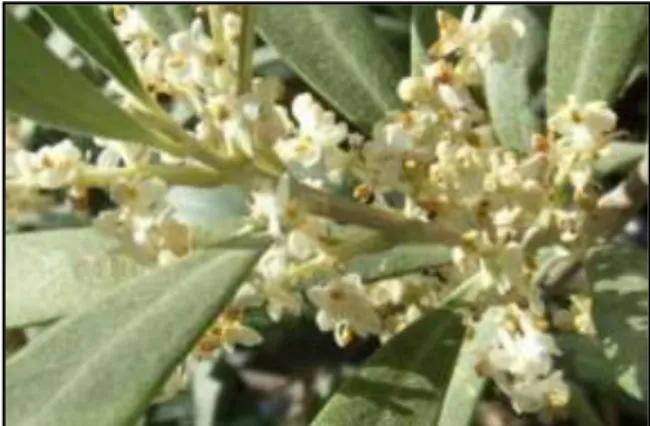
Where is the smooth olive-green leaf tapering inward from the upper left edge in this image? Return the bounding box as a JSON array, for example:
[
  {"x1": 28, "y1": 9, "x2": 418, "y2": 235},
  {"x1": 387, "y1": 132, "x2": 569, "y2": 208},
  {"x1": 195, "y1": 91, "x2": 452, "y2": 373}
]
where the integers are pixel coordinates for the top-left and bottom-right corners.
[{"x1": 5, "y1": 14, "x2": 155, "y2": 142}]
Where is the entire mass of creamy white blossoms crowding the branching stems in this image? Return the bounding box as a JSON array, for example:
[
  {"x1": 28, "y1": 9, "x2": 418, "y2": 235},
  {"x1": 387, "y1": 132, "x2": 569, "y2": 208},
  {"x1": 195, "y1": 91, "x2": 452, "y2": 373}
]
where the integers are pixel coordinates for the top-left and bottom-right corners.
[{"x1": 6, "y1": 6, "x2": 616, "y2": 412}]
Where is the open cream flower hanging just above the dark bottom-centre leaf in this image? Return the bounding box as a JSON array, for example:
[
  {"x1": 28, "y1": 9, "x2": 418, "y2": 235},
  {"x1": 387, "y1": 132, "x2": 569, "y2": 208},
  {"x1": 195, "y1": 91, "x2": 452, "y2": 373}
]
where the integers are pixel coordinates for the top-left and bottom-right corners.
[{"x1": 307, "y1": 274, "x2": 381, "y2": 336}]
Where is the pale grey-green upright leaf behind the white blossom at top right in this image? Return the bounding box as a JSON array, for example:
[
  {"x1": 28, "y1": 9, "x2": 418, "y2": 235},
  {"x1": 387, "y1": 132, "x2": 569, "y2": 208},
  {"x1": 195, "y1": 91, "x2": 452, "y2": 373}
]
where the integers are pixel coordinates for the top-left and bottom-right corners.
[{"x1": 484, "y1": 5, "x2": 546, "y2": 151}]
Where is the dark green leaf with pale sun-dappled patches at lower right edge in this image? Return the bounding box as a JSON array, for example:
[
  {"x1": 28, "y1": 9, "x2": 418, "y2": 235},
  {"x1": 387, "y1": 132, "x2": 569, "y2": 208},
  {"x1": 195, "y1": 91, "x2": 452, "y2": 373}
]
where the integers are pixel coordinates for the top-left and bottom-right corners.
[{"x1": 556, "y1": 245, "x2": 648, "y2": 409}]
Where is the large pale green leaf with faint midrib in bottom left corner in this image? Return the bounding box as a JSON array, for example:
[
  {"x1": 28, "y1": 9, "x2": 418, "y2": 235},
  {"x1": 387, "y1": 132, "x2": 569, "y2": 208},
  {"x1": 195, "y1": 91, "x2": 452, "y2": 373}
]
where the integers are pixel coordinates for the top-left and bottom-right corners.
[{"x1": 5, "y1": 249, "x2": 260, "y2": 426}]
